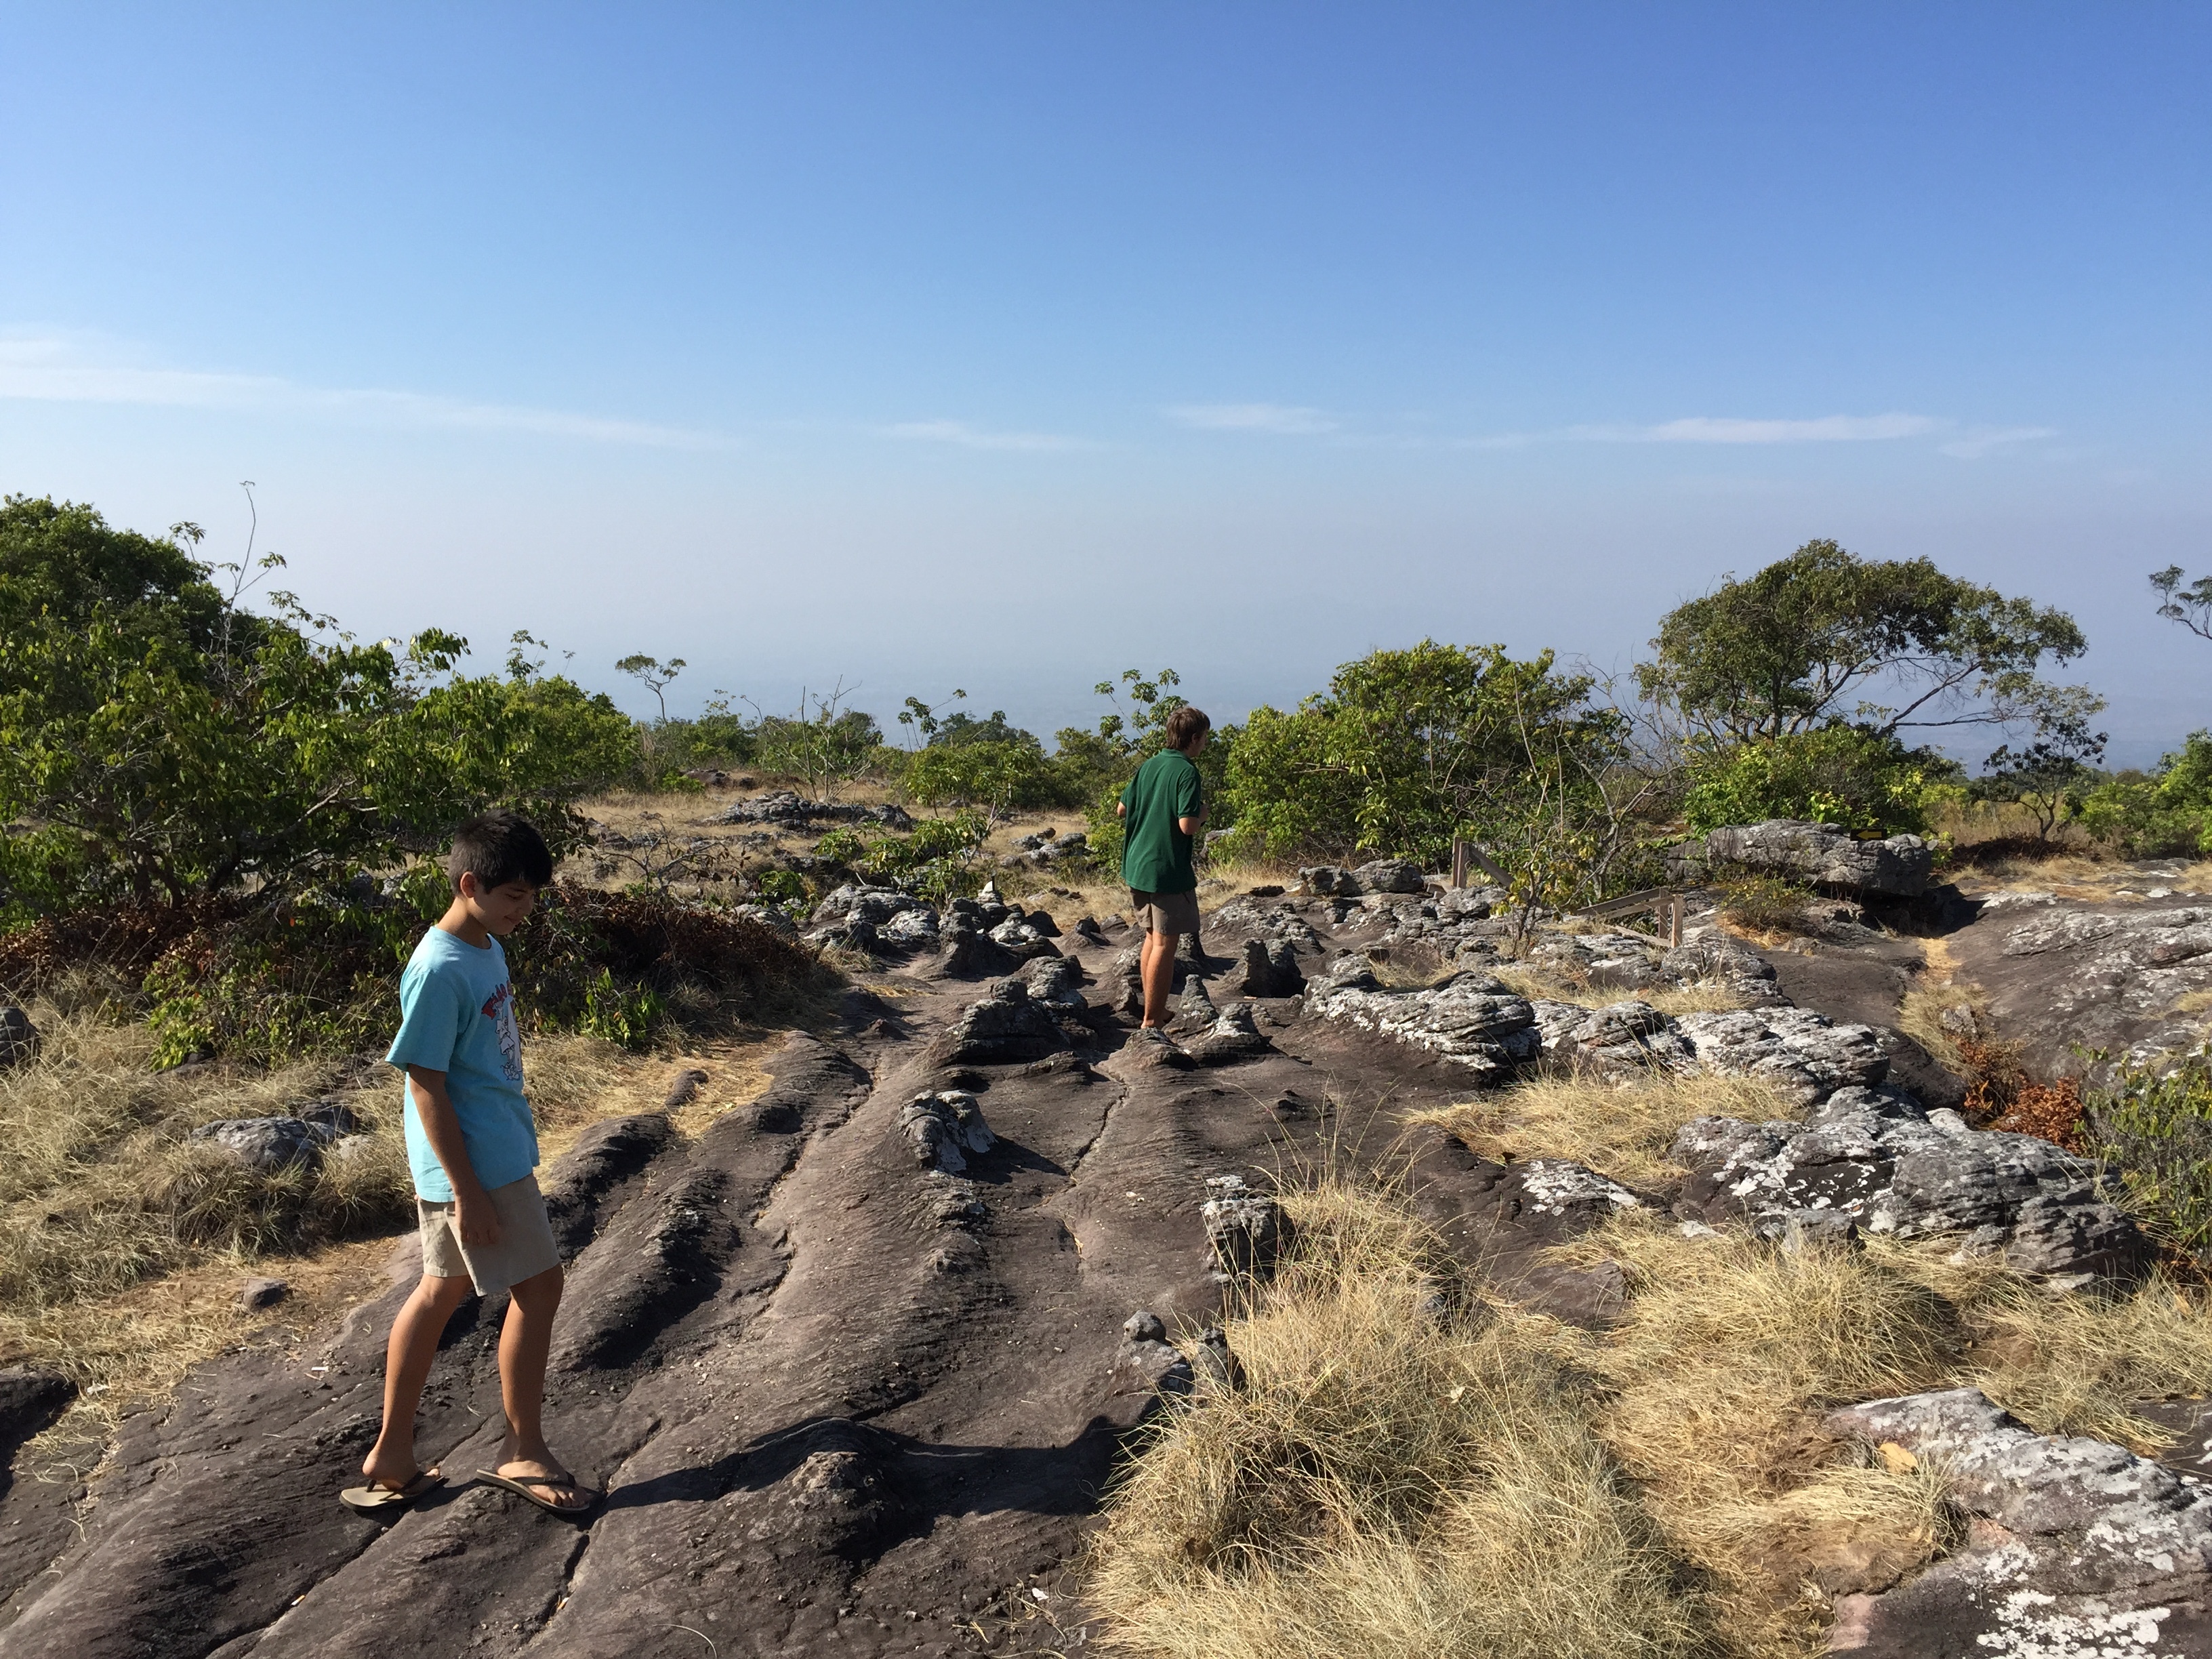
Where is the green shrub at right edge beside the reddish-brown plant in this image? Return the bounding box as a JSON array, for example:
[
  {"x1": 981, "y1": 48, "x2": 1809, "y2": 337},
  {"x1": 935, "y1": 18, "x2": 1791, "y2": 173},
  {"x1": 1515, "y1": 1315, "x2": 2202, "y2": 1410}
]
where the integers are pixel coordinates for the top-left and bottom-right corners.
[{"x1": 2084, "y1": 1055, "x2": 2212, "y2": 1265}]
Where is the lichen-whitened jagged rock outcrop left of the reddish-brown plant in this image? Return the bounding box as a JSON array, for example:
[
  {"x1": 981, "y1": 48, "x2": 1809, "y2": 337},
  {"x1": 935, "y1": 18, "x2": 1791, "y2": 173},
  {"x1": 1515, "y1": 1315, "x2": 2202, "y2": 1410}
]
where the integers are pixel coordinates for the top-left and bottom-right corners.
[{"x1": 1668, "y1": 1088, "x2": 2152, "y2": 1283}]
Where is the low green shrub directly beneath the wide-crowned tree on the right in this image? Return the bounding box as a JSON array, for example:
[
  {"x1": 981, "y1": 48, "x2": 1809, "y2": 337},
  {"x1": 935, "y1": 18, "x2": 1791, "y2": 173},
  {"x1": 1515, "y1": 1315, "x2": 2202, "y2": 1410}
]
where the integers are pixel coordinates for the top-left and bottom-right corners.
[{"x1": 1683, "y1": 726, "x2": 1958, "y2": 836}]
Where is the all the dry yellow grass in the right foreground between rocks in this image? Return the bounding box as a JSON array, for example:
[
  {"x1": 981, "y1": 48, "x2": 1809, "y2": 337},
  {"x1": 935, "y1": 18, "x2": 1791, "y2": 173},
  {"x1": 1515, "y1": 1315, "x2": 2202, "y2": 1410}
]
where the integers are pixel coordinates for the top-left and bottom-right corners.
[{"x1": 1115, "y1": 1078, "x2": 2212, "y2": 1659}]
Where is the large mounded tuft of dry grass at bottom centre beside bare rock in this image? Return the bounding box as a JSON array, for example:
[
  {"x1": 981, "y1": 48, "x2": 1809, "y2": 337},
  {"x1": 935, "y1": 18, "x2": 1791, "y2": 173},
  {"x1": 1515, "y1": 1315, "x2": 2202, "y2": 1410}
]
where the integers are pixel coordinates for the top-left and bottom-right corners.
[{"x1": 1088, "y1": 1176, "x2": 1703, "y2": 1659}]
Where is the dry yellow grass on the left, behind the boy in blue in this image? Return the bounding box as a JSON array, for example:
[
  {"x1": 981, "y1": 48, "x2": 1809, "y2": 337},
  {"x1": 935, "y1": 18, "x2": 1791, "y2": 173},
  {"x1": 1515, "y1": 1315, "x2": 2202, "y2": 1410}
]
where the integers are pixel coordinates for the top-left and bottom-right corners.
[{"x1": 0, "y1": 1004, "x2": 781, "y2": 1440}]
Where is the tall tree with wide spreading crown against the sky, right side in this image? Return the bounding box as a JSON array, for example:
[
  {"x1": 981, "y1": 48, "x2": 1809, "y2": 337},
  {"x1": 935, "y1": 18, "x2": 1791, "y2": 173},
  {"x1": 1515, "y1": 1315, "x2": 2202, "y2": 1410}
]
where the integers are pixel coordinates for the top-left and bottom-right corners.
[{"x1": 1637, "y1": 539, "x2": 2086, "y2": 743}]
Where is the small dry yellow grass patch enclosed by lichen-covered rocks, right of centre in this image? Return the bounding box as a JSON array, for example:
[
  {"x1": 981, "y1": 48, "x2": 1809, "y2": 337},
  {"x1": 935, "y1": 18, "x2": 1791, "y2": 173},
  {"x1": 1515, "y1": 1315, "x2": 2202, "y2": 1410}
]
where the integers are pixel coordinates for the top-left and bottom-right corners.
[{"x1": 1409, "y1": 1071, "x2": 1790, "y2": 1190}]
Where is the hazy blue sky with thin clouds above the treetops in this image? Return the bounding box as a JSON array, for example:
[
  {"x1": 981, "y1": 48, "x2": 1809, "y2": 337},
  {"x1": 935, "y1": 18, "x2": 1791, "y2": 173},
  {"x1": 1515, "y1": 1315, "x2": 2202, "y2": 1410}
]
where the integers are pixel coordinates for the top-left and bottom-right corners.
[{"x1": 0, "y1": 2, "x2": 2212, "y2": 761}]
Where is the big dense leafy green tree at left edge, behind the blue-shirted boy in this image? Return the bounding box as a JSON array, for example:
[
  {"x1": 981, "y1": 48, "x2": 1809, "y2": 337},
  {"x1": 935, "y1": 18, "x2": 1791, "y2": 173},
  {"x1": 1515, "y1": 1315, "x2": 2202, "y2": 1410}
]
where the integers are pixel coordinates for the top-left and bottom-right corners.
[{"x1": 0, "y1": 497, "x2": 633, "y2": 922}]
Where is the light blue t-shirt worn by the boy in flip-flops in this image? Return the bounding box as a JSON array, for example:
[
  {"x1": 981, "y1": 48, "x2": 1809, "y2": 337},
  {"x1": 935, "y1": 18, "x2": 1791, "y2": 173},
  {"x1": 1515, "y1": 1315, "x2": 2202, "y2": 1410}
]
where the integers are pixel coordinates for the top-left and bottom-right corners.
[{"x1": 385, "y1": 927, "x2": 537, "y2": 1204}]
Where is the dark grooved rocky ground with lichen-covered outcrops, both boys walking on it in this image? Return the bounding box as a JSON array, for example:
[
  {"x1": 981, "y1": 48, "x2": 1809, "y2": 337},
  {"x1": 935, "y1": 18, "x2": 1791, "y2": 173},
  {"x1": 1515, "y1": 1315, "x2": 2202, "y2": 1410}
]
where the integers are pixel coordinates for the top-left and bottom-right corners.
[{"x1": 0, "y1": 872, "x2": 2212, "y2": 1659}]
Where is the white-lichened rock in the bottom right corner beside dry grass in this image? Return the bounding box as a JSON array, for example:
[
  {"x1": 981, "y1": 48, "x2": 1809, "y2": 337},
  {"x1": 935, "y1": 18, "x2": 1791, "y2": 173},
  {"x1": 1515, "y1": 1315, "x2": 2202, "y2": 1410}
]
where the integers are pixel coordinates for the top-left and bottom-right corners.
[{"x1": 1827, "y1": 1389, "x2": 2212, "y2": 1659}]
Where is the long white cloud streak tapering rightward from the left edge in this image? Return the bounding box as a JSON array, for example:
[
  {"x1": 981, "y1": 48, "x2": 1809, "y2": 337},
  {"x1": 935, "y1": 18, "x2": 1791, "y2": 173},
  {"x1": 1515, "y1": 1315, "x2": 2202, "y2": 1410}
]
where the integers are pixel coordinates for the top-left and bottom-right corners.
[{"x1": 0, "y1": 334, "x2": 737, "y2": 449}]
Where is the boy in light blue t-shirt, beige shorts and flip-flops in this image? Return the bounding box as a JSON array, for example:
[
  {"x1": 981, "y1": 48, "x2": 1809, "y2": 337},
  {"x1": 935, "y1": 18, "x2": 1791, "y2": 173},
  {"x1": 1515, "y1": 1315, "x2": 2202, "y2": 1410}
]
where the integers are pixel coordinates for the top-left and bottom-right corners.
[{"x1": 341, "y1": 812, "x2": 600, "y2": 1515}]
